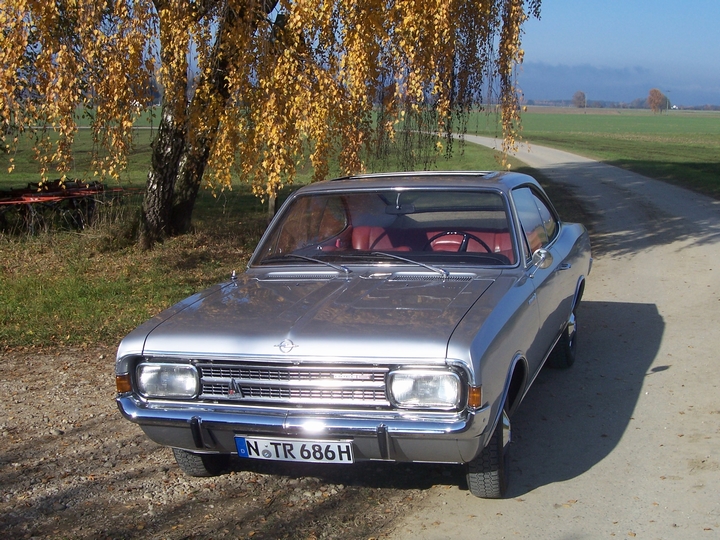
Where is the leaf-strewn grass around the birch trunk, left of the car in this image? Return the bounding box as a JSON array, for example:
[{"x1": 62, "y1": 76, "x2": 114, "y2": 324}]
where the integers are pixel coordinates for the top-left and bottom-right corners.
[{"x1": 0, "y1": 130, "x2": 524, "y2": 351}]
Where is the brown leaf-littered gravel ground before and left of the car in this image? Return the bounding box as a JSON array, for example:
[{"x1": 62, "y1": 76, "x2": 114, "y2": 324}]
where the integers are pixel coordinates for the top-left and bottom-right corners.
[{"x1": 0, "y1": 349, "x2": 470, "y2": 540}]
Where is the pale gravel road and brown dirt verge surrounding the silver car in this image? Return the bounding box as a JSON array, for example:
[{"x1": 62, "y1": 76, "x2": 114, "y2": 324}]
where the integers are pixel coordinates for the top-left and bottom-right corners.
[{"x1": 0, "y1": 140, "x2": 720, "y2": 540}]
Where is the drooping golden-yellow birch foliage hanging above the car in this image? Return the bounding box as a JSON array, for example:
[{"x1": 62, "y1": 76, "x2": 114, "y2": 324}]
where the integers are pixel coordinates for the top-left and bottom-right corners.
[{"x1": 0, "y1": 0, "x2": 538, "y2": 196}]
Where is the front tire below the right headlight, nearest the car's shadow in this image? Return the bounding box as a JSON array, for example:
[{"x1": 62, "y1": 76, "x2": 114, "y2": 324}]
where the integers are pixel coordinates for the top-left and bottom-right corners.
[{"x1": 467, "y1": 410, "x2": 511, "y2": 499}]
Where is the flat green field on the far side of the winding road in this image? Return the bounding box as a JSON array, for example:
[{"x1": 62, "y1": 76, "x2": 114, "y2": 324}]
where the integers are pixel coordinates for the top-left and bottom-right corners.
[{"x1": 468, "y1": 107, "x2": 720, "y2": 198}]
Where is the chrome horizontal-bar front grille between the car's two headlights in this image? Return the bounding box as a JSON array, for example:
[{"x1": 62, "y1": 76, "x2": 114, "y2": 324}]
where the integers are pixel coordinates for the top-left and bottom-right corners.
[{"x1": 196, "y1": 362, "x2": 390, "y2": 407}]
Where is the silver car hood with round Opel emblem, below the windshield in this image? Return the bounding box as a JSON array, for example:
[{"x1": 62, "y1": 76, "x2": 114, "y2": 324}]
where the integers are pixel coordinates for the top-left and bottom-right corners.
[{"x1": 138, "y1": 271, "x2": 500, "y2": 359}]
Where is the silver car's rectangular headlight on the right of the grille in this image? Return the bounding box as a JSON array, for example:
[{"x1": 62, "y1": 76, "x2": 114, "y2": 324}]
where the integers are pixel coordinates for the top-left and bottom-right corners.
[{"x1": 388, "y1": 369, "x2": 462, "y2": 409}]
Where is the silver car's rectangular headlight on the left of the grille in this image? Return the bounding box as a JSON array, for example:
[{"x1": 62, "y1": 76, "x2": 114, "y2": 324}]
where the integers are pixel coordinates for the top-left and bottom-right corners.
[{"x1": 136, "y1": 363, "x2": 200, "y2": 398}]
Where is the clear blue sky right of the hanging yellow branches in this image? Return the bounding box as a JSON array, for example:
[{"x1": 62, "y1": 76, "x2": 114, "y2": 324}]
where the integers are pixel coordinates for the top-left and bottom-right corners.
[{"x1": 518, "y1": 0, "x2": 720, "y2": 105}]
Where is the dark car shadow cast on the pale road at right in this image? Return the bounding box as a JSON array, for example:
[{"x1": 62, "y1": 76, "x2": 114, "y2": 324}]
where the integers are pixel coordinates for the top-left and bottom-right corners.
[{"x1": 500, "y1": 302, "x2": 673, "y2": 497}]
